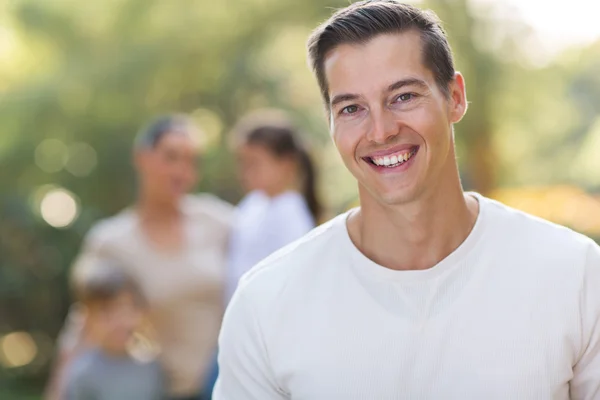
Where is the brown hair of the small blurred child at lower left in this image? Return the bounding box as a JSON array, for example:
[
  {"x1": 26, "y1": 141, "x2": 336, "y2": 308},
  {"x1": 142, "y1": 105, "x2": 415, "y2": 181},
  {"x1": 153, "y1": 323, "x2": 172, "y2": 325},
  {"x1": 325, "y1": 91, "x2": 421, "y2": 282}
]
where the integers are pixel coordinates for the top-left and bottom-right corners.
[{"x1": 72, "y1": 258, "x2": 146, "y2": 307}]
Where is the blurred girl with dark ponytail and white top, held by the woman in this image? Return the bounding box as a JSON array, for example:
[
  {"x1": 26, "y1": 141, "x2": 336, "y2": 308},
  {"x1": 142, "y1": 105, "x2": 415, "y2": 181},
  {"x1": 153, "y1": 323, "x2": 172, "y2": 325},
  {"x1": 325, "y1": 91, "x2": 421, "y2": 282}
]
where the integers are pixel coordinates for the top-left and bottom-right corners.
[{"x1": 206, "y1": 110, "x2": 321, "y2": 396}]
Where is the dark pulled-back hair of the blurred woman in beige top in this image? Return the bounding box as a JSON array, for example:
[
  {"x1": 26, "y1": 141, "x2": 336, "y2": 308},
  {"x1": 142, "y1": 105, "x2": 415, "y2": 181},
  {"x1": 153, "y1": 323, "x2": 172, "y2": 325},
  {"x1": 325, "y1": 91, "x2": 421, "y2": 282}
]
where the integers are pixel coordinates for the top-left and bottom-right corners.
[{"x1": 134, "y1": 114, "x2": 198, "y2": 150}]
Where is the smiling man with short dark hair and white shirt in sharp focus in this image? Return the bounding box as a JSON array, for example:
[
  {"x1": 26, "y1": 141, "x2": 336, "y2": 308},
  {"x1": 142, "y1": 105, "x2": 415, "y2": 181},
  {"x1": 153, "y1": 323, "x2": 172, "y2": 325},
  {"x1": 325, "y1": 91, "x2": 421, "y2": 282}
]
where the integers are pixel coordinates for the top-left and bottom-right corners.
[{"x1": 215, "y1": 0, "x2": 600, "y2": 400}]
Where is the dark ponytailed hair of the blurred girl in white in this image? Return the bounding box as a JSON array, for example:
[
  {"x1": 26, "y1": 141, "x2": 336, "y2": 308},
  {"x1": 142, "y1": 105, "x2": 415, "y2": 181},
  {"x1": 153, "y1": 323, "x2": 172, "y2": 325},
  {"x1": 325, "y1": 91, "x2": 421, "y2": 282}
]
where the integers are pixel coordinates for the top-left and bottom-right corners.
[{"x1": 235, "y1": 110, "x2": 322, "y2": 222}]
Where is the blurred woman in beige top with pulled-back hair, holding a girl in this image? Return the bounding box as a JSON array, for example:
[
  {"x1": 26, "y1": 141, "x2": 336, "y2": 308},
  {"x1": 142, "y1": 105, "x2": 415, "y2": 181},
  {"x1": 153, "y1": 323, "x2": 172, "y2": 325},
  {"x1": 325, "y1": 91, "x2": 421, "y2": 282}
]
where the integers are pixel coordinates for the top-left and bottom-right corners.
[{"x1": 47, "y1": 115, "x2": 233, "y2": 400}]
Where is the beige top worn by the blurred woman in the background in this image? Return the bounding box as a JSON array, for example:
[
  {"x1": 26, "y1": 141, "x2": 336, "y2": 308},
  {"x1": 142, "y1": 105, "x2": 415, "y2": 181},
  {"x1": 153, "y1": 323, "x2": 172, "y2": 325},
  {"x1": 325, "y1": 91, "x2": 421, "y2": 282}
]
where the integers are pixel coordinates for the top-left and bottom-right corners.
[{"x1": 66, "y1": 195, "x2": 233, "y2": 396}]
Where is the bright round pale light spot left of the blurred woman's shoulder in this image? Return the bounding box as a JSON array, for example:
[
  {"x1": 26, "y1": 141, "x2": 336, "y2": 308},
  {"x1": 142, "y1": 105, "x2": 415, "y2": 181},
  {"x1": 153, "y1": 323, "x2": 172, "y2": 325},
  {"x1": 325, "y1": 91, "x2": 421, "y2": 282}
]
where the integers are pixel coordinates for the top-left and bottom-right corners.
[{"x1": 40, "y1": 188, "x2": 79, "y2": 228}]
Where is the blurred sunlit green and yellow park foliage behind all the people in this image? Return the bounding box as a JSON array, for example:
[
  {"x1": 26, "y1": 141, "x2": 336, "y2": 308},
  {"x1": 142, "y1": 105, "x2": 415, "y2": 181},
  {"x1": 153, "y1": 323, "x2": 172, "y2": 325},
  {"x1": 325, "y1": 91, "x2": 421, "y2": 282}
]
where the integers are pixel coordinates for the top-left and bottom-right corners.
[{"x1": 0, "y1": 0, "x2": 600, "y2": 399}]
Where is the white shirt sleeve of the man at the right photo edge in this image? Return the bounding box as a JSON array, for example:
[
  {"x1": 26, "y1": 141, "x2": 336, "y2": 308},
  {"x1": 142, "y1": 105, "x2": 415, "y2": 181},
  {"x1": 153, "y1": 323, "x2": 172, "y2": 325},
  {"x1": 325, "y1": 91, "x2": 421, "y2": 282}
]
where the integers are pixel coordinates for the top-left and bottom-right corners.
[{"x1": 570, "y1": 239, "x2": 600, "y2": 400}]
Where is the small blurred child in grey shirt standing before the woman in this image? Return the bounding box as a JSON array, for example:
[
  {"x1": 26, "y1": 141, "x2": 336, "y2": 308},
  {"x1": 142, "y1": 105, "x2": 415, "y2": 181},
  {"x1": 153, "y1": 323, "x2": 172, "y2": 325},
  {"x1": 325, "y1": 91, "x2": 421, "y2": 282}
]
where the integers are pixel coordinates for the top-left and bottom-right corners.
[{"x1": 65, "y1": 260, "x2": 165, "y2": 400}]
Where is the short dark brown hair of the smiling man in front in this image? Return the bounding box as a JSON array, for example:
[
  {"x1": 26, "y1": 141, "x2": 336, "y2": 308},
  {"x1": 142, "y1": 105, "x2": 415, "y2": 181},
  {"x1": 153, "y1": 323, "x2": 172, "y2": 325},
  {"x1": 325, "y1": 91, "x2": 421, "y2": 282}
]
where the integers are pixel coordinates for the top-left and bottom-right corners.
[{"x1": 308, "y1": 0, "x2": 455, "y2": 106}]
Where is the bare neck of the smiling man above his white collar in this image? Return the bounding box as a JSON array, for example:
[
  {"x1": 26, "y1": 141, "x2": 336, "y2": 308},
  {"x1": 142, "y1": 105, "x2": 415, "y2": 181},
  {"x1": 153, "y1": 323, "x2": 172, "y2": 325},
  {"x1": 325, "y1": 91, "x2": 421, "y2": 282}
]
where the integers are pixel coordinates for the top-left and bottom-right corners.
[{"x1": 348, "y1": 184, "x2": 479, "y2": 270}]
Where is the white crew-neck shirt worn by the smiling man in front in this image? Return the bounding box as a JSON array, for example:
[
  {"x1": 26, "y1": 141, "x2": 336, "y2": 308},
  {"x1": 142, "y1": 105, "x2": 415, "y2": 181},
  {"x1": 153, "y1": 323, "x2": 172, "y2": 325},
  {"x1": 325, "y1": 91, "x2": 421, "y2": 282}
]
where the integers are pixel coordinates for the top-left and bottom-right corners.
[{"x1": 214, "y1": 195, "x2": 600, "y2": 400}]
